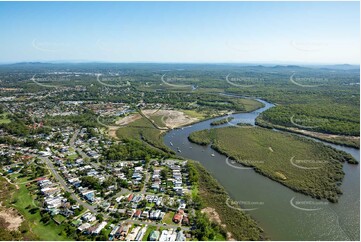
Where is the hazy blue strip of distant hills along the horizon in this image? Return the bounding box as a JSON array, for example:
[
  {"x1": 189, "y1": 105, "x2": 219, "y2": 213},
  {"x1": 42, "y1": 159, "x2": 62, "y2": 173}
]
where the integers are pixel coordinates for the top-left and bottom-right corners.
[{"x1": 0, "y1": 61, "x2": 360, "y2": 72}]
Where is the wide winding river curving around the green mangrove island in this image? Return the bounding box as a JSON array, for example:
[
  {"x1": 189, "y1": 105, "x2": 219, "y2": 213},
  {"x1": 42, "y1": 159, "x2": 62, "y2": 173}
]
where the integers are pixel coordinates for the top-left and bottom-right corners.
[{"x1": 164, "y1": 99, "x2": 360, "y2": 240}]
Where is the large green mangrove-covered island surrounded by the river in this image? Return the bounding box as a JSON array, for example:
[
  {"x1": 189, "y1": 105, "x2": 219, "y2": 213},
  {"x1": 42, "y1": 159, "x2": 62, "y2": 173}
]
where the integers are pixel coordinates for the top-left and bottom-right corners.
[{"x1": 189, "y1": 127, "x2": 357, "y2": 202}]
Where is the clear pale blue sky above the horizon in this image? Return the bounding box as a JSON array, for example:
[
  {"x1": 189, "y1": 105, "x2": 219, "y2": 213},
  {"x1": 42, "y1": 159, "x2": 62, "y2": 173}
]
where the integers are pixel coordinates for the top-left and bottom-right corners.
[{"x1": 0, "y1": 1, "x2": 360, "y2": 64}]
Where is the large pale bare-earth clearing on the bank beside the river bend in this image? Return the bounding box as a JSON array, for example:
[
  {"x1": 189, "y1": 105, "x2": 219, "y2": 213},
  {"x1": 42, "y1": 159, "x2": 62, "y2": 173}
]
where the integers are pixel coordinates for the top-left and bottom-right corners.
[{"x1": 142, "y1": 109, "x2": 199, "y2": 129}]
